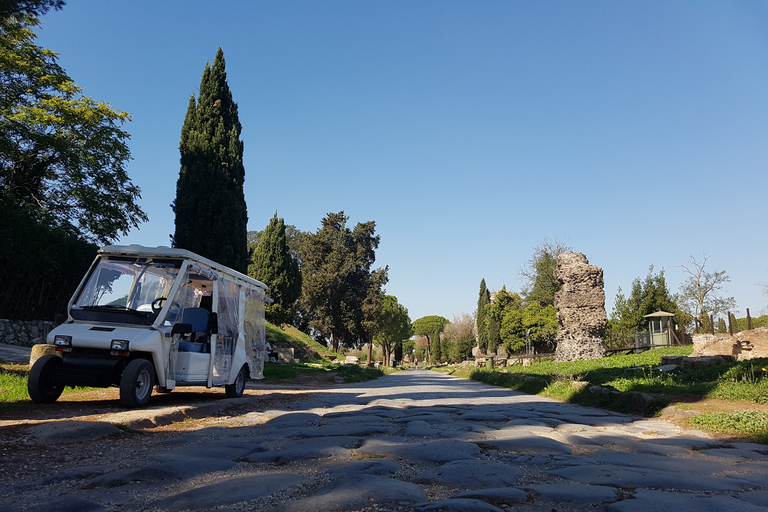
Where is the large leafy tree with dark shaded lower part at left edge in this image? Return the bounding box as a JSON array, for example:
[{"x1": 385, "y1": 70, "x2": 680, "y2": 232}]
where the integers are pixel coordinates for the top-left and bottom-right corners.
[{"x1": 0, "y1": 0, "x2": 142, "y2": 320}]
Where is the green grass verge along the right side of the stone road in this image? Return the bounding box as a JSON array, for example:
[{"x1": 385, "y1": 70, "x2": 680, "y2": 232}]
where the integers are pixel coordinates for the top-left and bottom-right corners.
[{"x1": 435, "y1": 346, "x2": 768, "y2": 443}]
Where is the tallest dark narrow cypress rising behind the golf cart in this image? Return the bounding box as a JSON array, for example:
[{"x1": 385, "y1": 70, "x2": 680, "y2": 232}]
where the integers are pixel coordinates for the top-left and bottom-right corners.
[{"x1": 171, "y1": 48, "x2": 248, "y2": 273}]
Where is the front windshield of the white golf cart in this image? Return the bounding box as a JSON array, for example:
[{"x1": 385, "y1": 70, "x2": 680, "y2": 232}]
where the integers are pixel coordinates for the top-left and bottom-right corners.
[{"x1": 70, "y1": 256, "x2": 182, "y2": 325}]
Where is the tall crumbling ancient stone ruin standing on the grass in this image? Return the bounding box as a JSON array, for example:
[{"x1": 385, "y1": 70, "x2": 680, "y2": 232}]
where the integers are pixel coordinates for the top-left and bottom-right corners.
[{"x1": 555, "y1": 252, "x2": 608, "y2": 361}]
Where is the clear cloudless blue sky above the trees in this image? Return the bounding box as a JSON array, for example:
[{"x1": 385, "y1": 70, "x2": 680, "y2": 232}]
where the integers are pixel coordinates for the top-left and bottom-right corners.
[{"x1": 33, "y1": 0, "x2": 768, "y2": 319}]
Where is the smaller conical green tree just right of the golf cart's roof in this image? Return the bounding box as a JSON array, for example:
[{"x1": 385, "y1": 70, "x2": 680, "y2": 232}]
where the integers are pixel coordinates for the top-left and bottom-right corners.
[{"x1": 248, "y1": 213, "x2": 301, "y2": 325}]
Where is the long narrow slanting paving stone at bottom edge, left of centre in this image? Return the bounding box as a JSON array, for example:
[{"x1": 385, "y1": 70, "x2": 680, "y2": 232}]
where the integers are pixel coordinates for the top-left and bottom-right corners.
[{"x1": 152, "y1": 473, "x2": 306, "y2": 511}]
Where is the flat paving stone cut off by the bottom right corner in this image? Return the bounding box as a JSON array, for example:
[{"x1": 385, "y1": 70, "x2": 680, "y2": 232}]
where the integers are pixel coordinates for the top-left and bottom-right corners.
[{"x1": 608, "y1": 489, "x2": 765, "y2": 512}]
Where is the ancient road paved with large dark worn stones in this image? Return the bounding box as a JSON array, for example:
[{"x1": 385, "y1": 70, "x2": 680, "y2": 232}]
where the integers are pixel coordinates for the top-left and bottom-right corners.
[{"x1": 0, "y1": 371, "x2": 768, "y2": 512}]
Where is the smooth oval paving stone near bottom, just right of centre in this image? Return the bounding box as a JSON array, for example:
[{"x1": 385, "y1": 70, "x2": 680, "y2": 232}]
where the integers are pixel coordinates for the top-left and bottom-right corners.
[{"x1": 412, "y1": 459, "x2": 523, "y2": 489}]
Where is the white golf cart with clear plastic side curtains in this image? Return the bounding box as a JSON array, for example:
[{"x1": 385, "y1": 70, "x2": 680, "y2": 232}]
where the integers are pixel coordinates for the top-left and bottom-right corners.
[{"x1": 28, "y1": 245, "x2": 271, "y2": 407}]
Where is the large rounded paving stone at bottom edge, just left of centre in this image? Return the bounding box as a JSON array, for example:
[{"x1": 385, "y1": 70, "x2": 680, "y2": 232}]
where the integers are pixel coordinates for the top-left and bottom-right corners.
[{"x1": 274, "y1": 475, "x2": 427, "y2": 512}]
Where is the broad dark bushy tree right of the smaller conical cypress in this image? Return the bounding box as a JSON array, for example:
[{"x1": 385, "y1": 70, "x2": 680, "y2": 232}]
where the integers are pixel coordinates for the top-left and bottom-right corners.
[{"x1": 299, "y1": 211, "x2": 389, "y2": 351}]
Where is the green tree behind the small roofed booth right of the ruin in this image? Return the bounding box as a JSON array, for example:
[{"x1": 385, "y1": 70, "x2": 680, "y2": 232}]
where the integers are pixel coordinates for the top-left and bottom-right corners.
[{"x1": 610, "y1": 265, "x2": 682, "y2": 332}]
